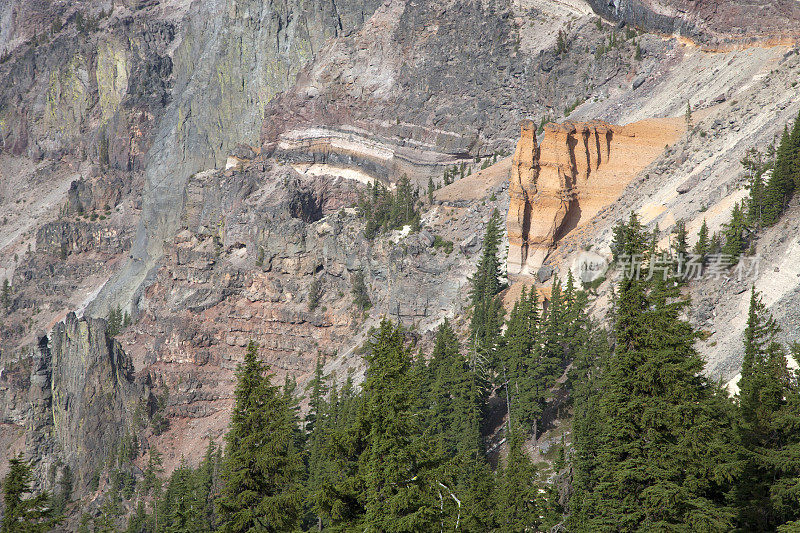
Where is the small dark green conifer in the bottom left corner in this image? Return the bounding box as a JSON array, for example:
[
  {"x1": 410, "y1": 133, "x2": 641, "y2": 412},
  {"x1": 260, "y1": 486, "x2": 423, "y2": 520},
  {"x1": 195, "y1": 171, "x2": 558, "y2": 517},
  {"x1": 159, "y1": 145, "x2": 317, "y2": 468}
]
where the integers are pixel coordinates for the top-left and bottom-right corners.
[{"x1": 0, "y1": 455, "x2": 61, "y2": 533}]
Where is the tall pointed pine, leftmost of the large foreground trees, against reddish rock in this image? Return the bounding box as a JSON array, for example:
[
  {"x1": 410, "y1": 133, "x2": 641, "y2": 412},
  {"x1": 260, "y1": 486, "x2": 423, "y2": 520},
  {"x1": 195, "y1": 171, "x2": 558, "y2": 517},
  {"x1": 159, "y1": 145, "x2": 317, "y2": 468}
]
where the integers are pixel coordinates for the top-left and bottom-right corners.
[{"x1": 217, "y1": 341, "x2": 302, "y2": 533}]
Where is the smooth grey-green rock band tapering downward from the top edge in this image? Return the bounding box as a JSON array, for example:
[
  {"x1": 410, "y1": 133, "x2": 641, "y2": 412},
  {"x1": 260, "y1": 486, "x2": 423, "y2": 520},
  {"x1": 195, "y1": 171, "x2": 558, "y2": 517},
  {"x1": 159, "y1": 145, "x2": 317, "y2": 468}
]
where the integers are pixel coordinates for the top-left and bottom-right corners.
[{"x1": 88, "y1": 0, "x2": 377, "y2": 315}]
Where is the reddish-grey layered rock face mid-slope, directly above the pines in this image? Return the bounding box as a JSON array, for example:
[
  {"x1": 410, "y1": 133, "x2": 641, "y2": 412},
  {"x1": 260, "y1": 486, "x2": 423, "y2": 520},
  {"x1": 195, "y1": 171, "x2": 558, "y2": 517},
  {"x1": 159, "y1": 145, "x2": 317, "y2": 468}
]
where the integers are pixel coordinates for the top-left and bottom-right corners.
[{"x1": 107, "y1": 161, "x2": 504, "y2": 468}]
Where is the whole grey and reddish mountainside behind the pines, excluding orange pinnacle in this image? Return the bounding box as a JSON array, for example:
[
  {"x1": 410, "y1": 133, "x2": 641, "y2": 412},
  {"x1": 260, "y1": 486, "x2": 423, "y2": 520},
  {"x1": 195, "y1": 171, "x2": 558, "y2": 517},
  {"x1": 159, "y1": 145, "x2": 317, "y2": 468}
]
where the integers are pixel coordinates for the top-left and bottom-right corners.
[{"x1": 0, "y1": 0, "x2": 800, "y2": 520}]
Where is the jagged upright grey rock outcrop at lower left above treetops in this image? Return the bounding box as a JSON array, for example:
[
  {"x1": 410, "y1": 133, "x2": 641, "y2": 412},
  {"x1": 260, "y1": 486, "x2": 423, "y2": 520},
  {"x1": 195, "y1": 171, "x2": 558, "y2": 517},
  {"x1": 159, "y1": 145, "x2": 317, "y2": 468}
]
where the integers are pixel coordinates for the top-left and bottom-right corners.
[{"x1": 0, "y1": 313, "x2": 154, "y2": 492}]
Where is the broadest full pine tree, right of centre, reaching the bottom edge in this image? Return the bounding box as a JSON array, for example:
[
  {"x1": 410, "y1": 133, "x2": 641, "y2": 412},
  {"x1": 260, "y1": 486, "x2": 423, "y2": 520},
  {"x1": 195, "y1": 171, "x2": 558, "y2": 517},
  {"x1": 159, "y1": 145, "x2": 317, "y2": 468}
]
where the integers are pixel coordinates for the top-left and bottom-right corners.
[{"x1": 575, "y1": 228, "x2": 733, "y2": 531}]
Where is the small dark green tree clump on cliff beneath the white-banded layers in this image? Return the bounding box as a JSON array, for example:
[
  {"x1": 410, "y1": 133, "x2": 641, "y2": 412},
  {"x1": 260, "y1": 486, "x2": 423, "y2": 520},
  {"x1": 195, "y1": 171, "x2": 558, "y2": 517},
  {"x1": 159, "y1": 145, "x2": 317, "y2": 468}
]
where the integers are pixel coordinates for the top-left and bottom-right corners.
[{"x1": 358, "y1": 176, "x2": 420, "y2": 239}]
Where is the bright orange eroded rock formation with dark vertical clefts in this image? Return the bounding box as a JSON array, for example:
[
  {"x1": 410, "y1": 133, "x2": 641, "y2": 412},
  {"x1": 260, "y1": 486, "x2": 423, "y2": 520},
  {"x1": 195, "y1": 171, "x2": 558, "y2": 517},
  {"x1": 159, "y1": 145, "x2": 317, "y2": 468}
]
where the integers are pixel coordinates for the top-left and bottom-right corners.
[{"x1": 507, "y1": 120, "x2": 681, "y2": 274}]
